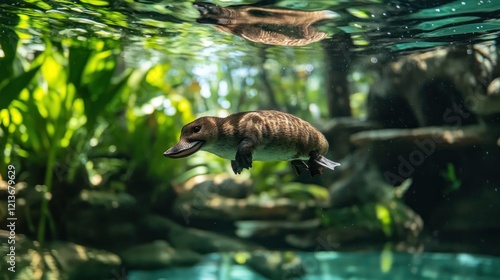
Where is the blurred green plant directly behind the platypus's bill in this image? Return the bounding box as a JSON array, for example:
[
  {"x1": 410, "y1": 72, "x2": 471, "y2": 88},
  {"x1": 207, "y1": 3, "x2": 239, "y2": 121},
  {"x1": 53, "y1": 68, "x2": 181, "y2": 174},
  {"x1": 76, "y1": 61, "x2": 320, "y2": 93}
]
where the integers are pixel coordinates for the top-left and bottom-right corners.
[{"x1": 108, "y1": 94, "x2": 194, "y2": 190}]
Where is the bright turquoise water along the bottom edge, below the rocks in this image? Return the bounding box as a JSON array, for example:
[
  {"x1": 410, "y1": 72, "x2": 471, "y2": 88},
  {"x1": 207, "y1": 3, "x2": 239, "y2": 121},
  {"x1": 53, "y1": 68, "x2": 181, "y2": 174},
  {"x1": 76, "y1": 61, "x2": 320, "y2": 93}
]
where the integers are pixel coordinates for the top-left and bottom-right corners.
[{"x1": 128, "y1": 252, "x2": 500, "y2": 280}]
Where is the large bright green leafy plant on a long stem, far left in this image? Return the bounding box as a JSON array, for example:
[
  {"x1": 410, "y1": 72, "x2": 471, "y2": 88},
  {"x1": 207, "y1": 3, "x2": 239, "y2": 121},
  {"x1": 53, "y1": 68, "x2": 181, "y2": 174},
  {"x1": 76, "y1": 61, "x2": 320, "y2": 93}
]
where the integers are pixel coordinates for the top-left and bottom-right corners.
[{"x1": 0, "y1": 34, "x2": 133, "y2": 243}]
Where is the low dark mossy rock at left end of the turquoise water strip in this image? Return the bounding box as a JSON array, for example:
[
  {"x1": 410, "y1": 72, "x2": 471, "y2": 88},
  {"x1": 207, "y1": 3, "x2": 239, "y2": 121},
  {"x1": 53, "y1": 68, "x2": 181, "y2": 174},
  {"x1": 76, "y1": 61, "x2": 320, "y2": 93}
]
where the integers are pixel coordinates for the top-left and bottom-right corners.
[{"x1": 119, "y1": 240, "x2": 201, "y2": 270}]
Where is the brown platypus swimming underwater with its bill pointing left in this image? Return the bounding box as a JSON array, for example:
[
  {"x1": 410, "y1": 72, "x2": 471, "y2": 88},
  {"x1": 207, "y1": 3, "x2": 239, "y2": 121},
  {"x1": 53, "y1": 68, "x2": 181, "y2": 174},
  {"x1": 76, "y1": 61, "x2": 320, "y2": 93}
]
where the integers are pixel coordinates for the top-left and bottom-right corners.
[{"x1": 163, "y1": 110, "x2": 340, "y2": 176}]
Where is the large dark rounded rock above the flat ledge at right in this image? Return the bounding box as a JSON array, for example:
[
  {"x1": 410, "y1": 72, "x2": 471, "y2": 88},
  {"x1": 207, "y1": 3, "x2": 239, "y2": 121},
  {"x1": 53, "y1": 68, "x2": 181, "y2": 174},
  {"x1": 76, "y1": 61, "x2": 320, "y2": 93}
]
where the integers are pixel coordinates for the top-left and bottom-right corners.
[{"x1": 368, "y1": 47, "x2": 480, "y2": 128}]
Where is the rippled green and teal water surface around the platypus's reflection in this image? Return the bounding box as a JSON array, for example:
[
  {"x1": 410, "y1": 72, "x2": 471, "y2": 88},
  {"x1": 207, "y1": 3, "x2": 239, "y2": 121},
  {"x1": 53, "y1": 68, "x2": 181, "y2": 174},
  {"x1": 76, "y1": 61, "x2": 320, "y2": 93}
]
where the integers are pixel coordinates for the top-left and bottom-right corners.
[{"x1": 1, "y1": 0, "x2": 498, "y2": 62}]
